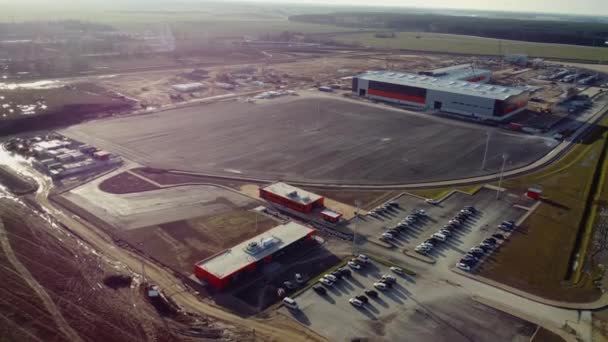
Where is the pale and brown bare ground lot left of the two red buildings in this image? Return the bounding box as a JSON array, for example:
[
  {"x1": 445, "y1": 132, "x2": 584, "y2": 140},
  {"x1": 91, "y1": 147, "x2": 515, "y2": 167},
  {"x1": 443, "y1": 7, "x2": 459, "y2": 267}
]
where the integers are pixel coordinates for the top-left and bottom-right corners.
[{"x1": 61, "y1": 171, "x2": 278, "y2": 274}]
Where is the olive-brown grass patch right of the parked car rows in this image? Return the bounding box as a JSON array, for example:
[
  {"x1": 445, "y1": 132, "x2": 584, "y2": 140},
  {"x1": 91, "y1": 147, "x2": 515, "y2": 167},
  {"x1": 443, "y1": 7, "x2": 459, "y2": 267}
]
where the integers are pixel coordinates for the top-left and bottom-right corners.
[{"x1": 479, "y1": 118, "x2": 608, "y2": 302}]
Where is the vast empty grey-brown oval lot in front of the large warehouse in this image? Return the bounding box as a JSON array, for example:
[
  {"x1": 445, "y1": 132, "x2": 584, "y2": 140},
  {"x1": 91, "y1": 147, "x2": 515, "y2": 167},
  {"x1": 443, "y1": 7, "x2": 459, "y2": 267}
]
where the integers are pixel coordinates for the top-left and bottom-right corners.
[{"x1": 62, "y1": 97, "x2": 552, "y2": 184}]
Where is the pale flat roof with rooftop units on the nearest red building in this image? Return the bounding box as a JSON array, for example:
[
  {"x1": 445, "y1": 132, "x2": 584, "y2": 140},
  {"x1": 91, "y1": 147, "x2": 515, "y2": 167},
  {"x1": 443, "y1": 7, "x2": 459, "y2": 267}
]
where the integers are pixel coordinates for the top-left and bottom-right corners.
[{"x1": 196, "y1": 222, "x2": 315, "y2": 278}]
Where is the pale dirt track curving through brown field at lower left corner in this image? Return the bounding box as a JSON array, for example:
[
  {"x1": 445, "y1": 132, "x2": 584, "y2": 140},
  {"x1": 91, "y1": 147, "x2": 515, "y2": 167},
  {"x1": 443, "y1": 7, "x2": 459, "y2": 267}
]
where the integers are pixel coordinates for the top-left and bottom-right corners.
[{"x1": 0, "y1": 220, "x2": 82, "y2": 341}]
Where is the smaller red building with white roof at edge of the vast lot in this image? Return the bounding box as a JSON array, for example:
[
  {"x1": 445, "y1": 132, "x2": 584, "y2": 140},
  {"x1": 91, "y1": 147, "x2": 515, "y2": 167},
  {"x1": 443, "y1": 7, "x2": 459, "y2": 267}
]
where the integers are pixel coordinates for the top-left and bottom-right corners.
[{"x1": 260, "y1": 182, "x2": 323, "y2": 213}]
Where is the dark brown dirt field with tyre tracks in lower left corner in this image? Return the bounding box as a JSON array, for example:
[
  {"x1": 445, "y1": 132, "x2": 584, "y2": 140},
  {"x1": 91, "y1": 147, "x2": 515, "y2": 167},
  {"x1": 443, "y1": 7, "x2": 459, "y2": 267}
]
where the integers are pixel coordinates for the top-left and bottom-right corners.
[{"x1": 0, "y1": 198, "x2": 245, "y2": 341}]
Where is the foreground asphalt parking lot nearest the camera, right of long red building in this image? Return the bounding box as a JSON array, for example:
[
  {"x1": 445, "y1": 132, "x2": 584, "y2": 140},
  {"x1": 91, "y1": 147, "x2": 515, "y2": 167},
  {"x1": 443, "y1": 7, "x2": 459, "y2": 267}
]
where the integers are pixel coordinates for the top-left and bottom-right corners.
[{"x1": 279, "y1": 261, "x2": 534, "y2": 341}]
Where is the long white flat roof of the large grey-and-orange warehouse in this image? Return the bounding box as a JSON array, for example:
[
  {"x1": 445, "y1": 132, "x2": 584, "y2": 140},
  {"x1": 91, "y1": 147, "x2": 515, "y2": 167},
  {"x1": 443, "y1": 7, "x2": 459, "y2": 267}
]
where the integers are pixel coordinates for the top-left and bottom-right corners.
[{"x1": 357, "y1": 71, "x2": 526, "y2": 100}]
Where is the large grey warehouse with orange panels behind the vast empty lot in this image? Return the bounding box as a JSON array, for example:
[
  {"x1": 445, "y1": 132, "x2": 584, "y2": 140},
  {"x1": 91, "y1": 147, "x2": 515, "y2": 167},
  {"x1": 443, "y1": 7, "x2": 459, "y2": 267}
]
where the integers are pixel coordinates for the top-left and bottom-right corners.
[{"x1": 352, "y1": 69, "x2": 528, "y2": 121}]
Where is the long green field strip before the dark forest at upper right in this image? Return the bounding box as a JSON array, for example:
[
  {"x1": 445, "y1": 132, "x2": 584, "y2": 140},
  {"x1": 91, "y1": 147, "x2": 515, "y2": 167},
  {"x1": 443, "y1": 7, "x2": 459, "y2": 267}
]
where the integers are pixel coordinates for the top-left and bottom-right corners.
[{"x1": 333, "y1": 32, "x2": 608, "y2": 62}]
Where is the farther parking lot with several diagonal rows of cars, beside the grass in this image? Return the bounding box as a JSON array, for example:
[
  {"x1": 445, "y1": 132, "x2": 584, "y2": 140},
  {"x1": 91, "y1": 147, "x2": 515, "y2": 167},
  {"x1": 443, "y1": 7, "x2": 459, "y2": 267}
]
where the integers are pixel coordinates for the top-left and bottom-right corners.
[{"x1": 351, "y1": 188, "x2": 532, "y2": 270}]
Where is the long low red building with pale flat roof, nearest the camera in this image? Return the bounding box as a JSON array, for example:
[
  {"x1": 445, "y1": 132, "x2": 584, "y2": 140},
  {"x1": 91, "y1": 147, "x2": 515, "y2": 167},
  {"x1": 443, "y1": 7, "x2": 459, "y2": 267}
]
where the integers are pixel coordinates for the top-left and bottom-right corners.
[{"x1": 194, "y1": 222, "x2": 316, "y2": 289}]
